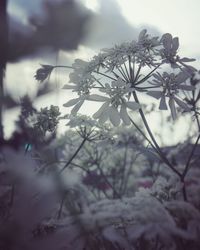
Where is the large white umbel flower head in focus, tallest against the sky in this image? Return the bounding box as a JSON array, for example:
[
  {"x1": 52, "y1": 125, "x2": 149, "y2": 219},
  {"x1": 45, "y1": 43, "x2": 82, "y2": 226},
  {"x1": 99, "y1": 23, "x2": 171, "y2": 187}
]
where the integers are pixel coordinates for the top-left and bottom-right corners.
[{"x1": 63, "y1": 30, "x2": 196, "y2": 123}]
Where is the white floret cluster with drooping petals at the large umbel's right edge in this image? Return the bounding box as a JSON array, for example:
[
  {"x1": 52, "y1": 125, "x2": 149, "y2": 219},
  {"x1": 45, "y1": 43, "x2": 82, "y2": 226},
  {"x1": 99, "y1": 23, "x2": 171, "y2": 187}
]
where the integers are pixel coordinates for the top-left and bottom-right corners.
[{"x1": 147, "y1": 72, "x2": 194, "y2": 120}]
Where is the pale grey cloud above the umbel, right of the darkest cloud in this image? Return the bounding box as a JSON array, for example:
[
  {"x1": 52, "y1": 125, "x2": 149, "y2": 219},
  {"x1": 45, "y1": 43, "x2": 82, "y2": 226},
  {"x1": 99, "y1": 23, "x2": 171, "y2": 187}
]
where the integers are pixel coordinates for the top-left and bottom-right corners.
[{"x1": 84, "y1": 0, "x2": 159, "y2": 49}]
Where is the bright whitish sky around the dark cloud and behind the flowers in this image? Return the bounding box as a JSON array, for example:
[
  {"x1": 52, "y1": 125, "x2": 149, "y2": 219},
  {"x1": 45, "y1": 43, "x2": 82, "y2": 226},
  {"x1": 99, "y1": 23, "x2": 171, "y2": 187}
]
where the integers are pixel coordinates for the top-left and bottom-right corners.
[{"x1": 5, "y1": 0, "x2": 200, "y2": 143}]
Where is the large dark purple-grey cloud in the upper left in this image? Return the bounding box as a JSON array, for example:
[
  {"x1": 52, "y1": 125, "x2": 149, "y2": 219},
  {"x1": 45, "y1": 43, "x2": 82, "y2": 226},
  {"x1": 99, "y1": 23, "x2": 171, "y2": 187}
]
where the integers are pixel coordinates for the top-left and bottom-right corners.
[{"x1": 8, "y1": 0, "x2": 89, "y2": 61}]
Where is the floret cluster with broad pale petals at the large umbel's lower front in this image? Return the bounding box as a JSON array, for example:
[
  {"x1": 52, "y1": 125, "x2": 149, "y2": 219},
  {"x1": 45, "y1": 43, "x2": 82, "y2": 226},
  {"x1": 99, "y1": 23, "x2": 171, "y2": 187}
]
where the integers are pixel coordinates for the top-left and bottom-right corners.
[{"x1": 63, "y1": 78, "x2": 140, "y2": 126}]
